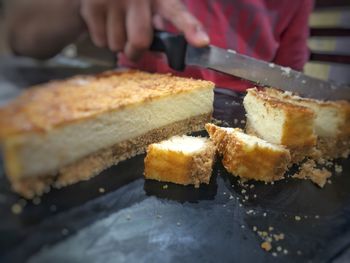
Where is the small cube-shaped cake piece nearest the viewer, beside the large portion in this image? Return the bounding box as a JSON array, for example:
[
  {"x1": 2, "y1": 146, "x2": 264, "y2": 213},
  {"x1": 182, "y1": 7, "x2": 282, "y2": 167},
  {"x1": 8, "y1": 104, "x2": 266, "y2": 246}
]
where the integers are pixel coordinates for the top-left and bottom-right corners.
[{"x1": 145, "y1": 136, "x2": 215, "y2": 187}]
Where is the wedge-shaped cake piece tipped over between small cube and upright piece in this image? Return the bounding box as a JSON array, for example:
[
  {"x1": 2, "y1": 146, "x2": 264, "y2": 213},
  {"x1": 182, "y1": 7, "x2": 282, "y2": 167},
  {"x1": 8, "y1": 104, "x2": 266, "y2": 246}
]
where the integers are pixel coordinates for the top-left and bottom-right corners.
[{"x1": 205, "y1": 124, "x2": 291, "y2": 182}]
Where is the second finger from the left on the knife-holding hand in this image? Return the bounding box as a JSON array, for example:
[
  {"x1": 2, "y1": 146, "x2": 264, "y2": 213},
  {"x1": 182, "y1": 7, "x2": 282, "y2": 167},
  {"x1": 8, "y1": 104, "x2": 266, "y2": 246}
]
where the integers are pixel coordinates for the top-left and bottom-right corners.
[{"x1": 107, "y1": 2, "x2": 126, "y2": 52}]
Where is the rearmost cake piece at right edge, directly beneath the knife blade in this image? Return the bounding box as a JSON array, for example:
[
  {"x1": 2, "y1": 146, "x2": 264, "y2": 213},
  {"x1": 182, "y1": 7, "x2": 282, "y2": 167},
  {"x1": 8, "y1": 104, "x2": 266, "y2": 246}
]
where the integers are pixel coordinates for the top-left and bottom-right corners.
[{"x1": 264, "y1": 88, "x2": 350, "y2": 159}]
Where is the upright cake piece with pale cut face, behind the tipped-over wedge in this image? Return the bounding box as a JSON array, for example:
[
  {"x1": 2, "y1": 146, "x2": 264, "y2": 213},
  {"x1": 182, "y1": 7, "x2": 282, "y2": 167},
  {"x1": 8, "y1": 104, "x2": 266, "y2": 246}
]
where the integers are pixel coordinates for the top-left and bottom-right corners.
[{"x1": 243, "y1": 88, "x2": 317, "y2": 163}]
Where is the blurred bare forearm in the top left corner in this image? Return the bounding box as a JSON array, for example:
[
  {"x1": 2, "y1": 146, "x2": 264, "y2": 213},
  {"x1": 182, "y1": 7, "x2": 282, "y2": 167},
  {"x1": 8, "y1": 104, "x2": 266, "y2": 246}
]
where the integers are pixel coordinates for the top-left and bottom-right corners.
[{"x1": 6, "y1": 0, "x2": 84, "y2": 58}]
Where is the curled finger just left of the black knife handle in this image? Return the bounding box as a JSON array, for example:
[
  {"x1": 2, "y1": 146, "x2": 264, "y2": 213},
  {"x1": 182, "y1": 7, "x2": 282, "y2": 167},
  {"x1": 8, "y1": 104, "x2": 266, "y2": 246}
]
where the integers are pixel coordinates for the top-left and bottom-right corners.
[{"x1": 124, "y1": 0, "x2": 153, "y2": 60}]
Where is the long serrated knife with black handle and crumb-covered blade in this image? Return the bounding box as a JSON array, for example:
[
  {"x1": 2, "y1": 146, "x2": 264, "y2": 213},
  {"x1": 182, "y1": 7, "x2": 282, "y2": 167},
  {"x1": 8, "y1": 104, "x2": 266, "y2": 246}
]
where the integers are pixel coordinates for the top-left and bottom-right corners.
[{"x1": 151, "y1": 31, "x2": 350, "y2": 100}]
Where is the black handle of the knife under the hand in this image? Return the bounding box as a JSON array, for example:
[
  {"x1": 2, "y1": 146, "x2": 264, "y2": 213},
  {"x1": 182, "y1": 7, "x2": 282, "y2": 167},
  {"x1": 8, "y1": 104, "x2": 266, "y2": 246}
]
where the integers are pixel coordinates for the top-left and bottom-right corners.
[{"x1": 150, "y1": 31, "x2": 187, "y2": 71}]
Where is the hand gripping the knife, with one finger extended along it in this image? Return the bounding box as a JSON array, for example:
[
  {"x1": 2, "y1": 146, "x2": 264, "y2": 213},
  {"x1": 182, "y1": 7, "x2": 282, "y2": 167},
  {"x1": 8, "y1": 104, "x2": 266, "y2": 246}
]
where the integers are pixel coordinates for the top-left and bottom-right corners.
[{"x1": 80, "y1": 0, "x2": 209, "y2": 60}]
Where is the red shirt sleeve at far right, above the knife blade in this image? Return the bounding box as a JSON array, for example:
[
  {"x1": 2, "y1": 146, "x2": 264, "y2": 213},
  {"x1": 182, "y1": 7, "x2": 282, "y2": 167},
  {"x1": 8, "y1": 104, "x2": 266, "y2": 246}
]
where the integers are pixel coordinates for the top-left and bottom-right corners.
[{"x1": 274, "y1": 0, "x2": 313, "y2": 70}]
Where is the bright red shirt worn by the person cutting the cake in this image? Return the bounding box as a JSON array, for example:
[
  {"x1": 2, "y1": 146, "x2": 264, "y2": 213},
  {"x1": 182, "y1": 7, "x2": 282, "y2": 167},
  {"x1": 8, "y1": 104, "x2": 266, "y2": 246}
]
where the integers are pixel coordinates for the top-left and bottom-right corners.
[{"x1": 120, "y1": 0, "x2": 313, "y2": 91}]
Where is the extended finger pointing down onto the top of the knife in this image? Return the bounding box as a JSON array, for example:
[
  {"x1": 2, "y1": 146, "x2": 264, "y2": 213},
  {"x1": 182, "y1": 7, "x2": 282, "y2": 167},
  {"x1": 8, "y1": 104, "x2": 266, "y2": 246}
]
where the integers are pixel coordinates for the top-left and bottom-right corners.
[{"x1": 156, "y1": 0, "x2": 210, "y2": 47}]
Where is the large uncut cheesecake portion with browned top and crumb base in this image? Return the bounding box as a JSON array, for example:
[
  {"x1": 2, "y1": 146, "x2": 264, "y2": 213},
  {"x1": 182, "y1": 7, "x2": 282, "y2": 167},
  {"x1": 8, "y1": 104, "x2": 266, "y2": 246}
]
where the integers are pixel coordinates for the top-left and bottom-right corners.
[{"x1": 0, "y1": 71, "x2": 214, "y2": 198}]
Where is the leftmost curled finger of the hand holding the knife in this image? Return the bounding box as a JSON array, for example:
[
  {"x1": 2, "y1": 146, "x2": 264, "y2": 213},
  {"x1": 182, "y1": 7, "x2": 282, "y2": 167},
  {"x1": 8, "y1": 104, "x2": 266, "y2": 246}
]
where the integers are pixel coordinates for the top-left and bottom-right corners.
[{"x1": 81, "y1": 1, "x2": 107, "y2": 47}]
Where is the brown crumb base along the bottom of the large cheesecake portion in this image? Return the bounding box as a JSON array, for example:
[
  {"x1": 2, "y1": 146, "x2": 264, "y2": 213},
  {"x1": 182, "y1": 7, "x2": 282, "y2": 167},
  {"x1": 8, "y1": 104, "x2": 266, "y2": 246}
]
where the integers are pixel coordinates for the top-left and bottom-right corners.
[{"x1": 10, "y1": 114, "x2": 211, "y2": 198}]
